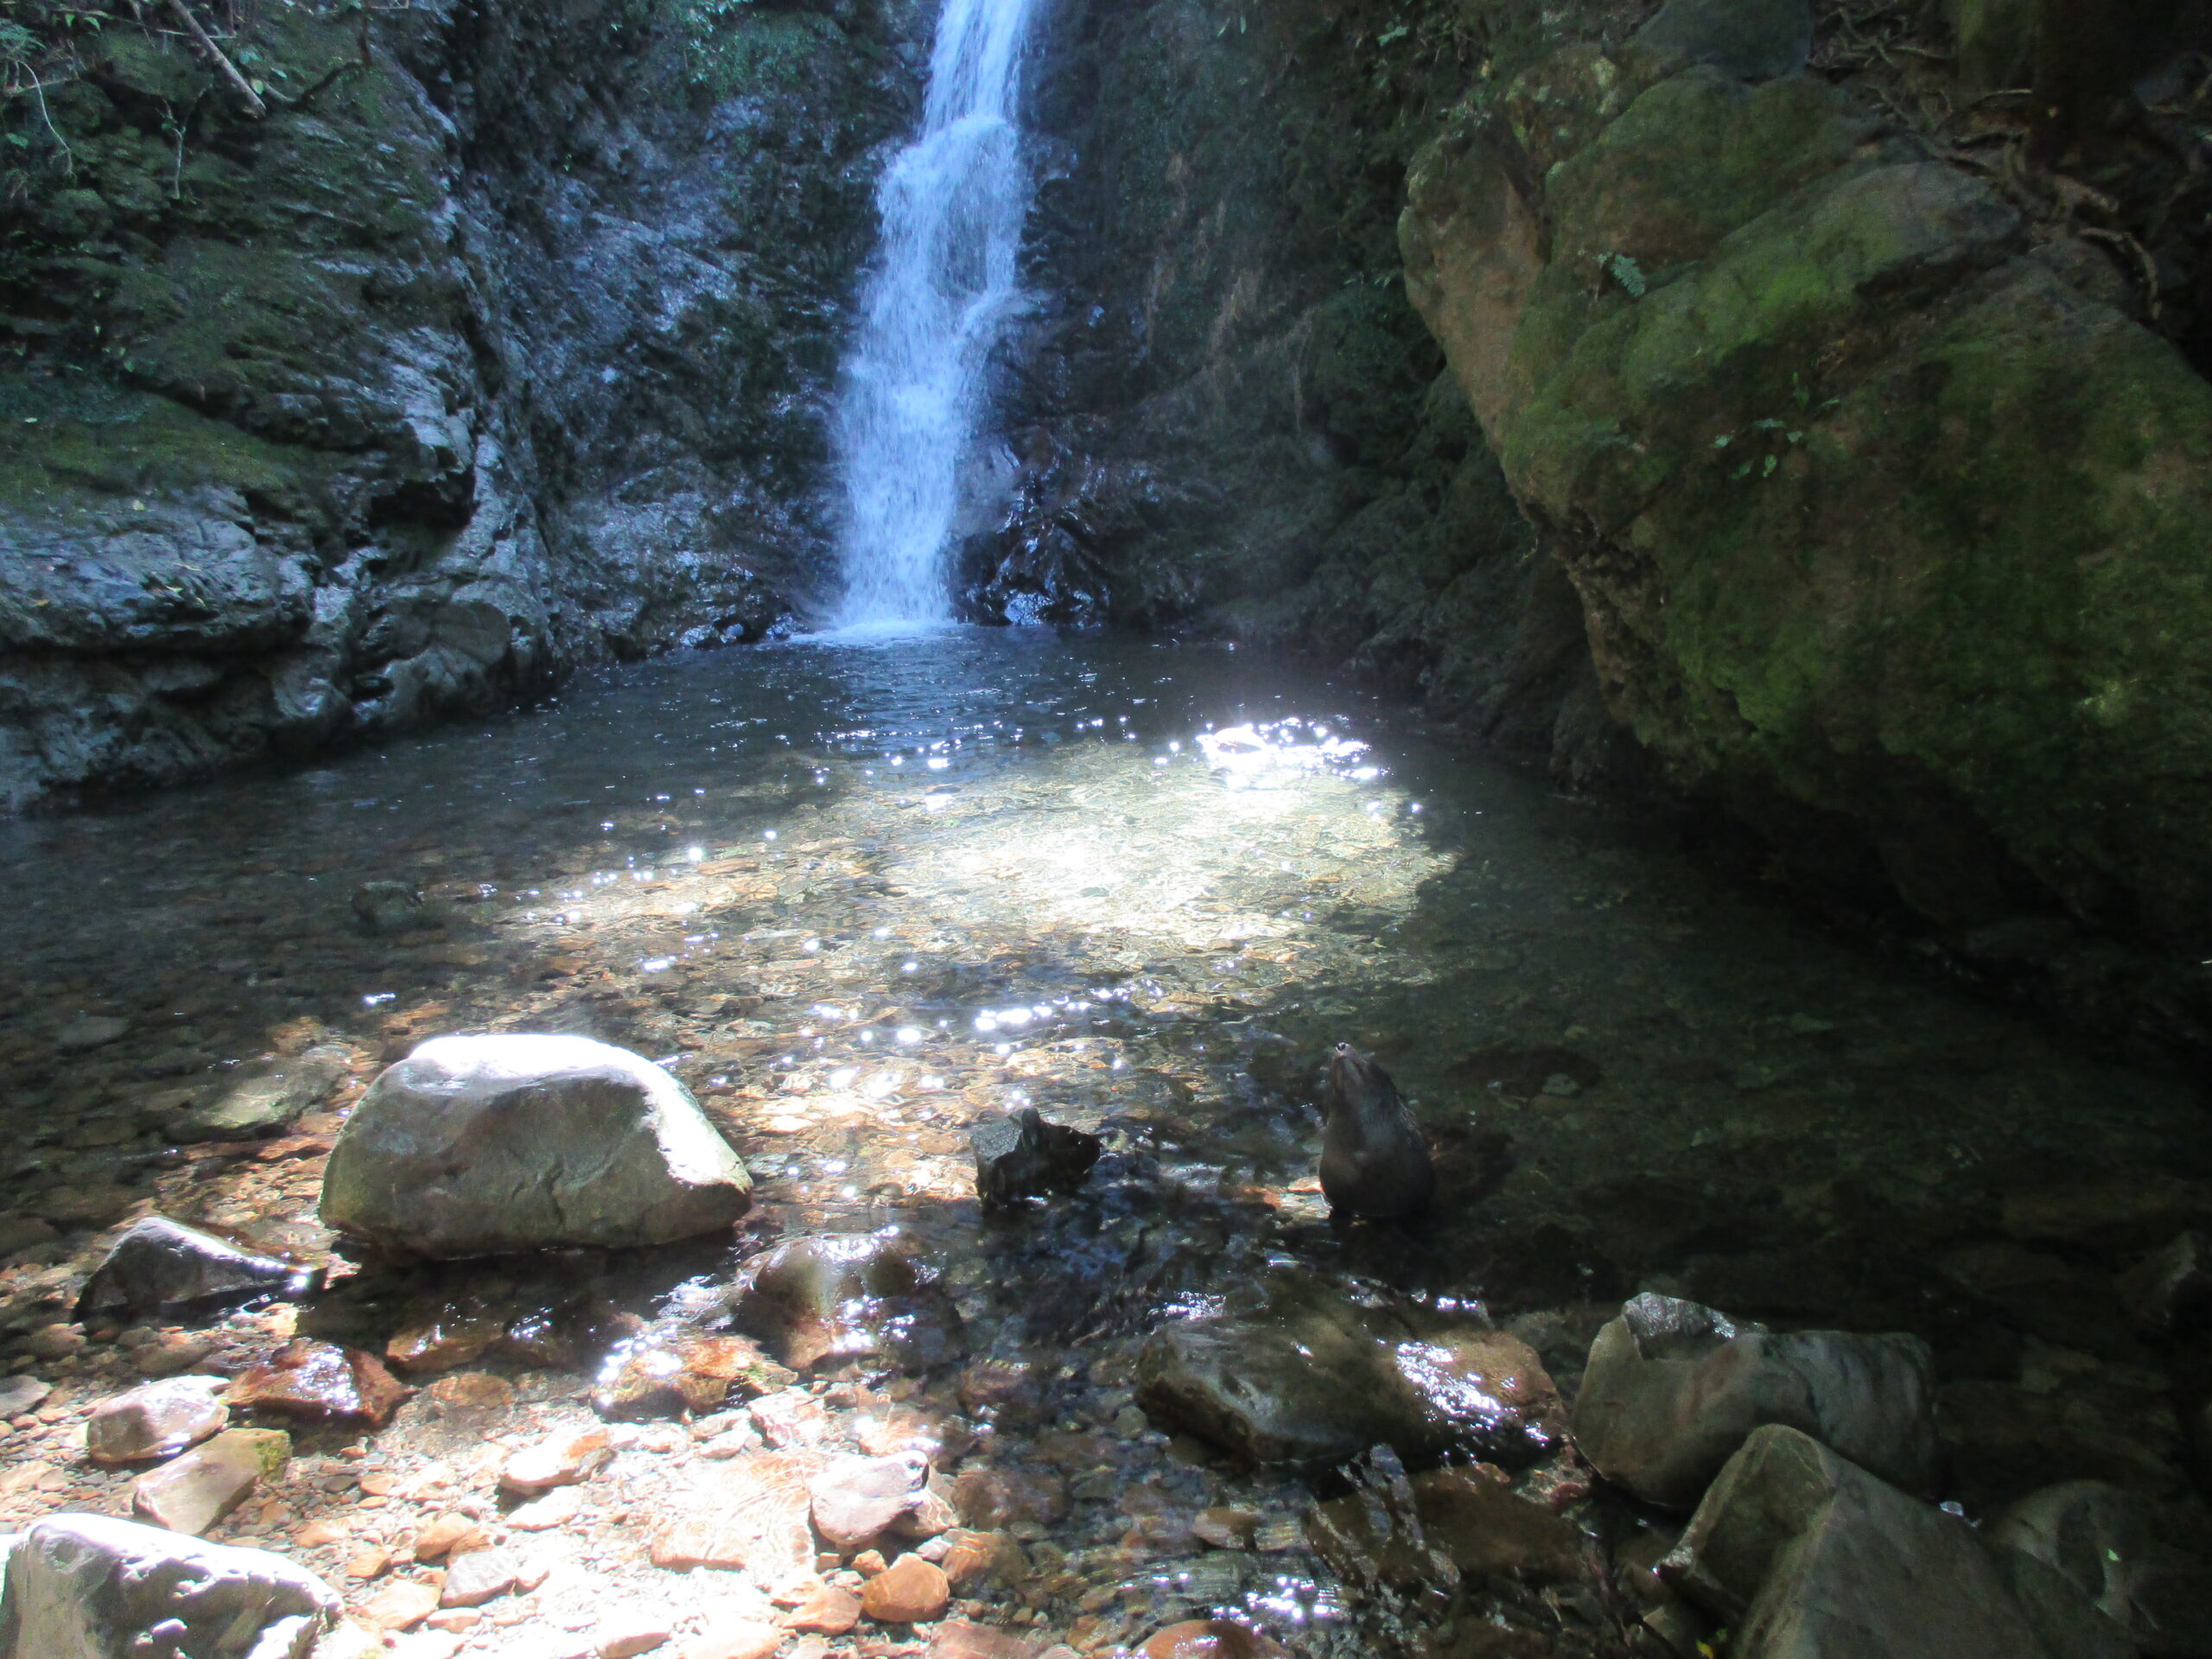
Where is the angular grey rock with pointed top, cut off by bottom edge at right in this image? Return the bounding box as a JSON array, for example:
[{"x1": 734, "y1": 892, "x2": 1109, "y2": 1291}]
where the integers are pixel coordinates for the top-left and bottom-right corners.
[{"x1": 1662, "y1": 1425, "x2": 2055, "y2": 1659}]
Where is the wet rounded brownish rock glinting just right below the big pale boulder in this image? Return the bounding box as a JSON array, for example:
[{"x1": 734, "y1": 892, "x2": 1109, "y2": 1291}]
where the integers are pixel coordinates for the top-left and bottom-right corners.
[{"x1": 732, "y1": 1232, "x2": 957, "y2": 1371}]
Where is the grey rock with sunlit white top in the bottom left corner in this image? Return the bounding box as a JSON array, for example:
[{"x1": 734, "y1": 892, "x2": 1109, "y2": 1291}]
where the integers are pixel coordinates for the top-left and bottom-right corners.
[{"x1": 0, "y1": 1516, "x2": 340, "y2": 1659}]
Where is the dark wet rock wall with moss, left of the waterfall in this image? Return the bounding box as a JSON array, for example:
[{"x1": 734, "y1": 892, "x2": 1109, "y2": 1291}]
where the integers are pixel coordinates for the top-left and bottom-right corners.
[{"x1": 0, "y1": 0, "x2": 925, "y2": 810}]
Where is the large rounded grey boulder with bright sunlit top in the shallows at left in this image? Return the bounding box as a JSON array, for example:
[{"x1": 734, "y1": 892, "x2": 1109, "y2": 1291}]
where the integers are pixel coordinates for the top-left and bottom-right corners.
[{"x1": 321, "y1": 1035, "x2": 752, "y2": 1256}]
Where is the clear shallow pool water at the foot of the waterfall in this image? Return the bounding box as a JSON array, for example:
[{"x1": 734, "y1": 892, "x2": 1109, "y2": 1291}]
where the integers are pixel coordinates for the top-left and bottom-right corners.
[{"x1": 0, "y1": 631, "x2": 2212, "y2": 1652}]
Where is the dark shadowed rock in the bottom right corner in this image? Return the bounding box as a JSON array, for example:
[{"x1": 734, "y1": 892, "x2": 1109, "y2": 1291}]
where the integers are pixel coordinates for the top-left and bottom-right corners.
[{"x1": 1988, "y1": 1480, "x2": 2212, "y2": 1659}]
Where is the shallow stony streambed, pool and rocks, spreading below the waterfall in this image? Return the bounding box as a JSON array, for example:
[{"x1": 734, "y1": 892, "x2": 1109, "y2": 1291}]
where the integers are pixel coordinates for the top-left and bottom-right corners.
[{"x1": 0, "y1": 632, "x2": 2212, "y2": 1659}]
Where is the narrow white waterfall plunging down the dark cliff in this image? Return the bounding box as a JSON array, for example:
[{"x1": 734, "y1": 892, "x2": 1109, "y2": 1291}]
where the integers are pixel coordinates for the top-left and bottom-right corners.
[{"x1": 832, "y1": 0, "x2": 1038, "y2": 626}]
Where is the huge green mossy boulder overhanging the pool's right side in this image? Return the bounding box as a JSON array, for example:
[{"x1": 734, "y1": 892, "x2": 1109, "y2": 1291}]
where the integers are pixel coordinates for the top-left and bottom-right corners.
[{"x1": 1402, "y1": 48, "x2": 2212, "y2": 986}]
